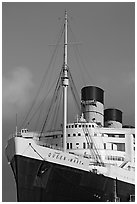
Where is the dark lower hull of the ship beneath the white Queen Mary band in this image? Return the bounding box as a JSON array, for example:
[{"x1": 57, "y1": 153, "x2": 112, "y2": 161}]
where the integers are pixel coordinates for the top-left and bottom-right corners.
[{"x1": 11, "y1": 156, "x2": 135, "y2": 202}]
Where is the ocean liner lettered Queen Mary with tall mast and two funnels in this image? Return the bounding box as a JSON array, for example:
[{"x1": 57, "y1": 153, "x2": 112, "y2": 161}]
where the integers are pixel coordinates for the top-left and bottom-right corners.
[{"x1": 5, "y1": 11, "x2": 135, "y2": 202}]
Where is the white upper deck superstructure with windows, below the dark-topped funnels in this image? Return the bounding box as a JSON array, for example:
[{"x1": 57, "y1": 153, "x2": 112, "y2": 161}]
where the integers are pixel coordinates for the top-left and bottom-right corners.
[{"x1": 14, "y1": 122, "x2": 135, "y2": 166}]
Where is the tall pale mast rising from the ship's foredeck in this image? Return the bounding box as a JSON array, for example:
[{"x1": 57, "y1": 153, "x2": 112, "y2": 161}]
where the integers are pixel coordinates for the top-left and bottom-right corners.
[{"x1": 62, "y1": 11, "x2": 69, "y2": 152}]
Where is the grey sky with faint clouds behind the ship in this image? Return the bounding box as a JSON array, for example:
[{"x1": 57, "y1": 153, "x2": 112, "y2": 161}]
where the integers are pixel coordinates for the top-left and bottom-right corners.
[{"x1": 2, "y1": 2, "x2": 135, "y2": 201}]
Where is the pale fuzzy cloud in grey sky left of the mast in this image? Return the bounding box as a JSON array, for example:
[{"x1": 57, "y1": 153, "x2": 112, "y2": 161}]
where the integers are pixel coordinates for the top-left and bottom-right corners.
[{"x1": 2, "y1": 67, "x2": 34, "y2": 119}]
